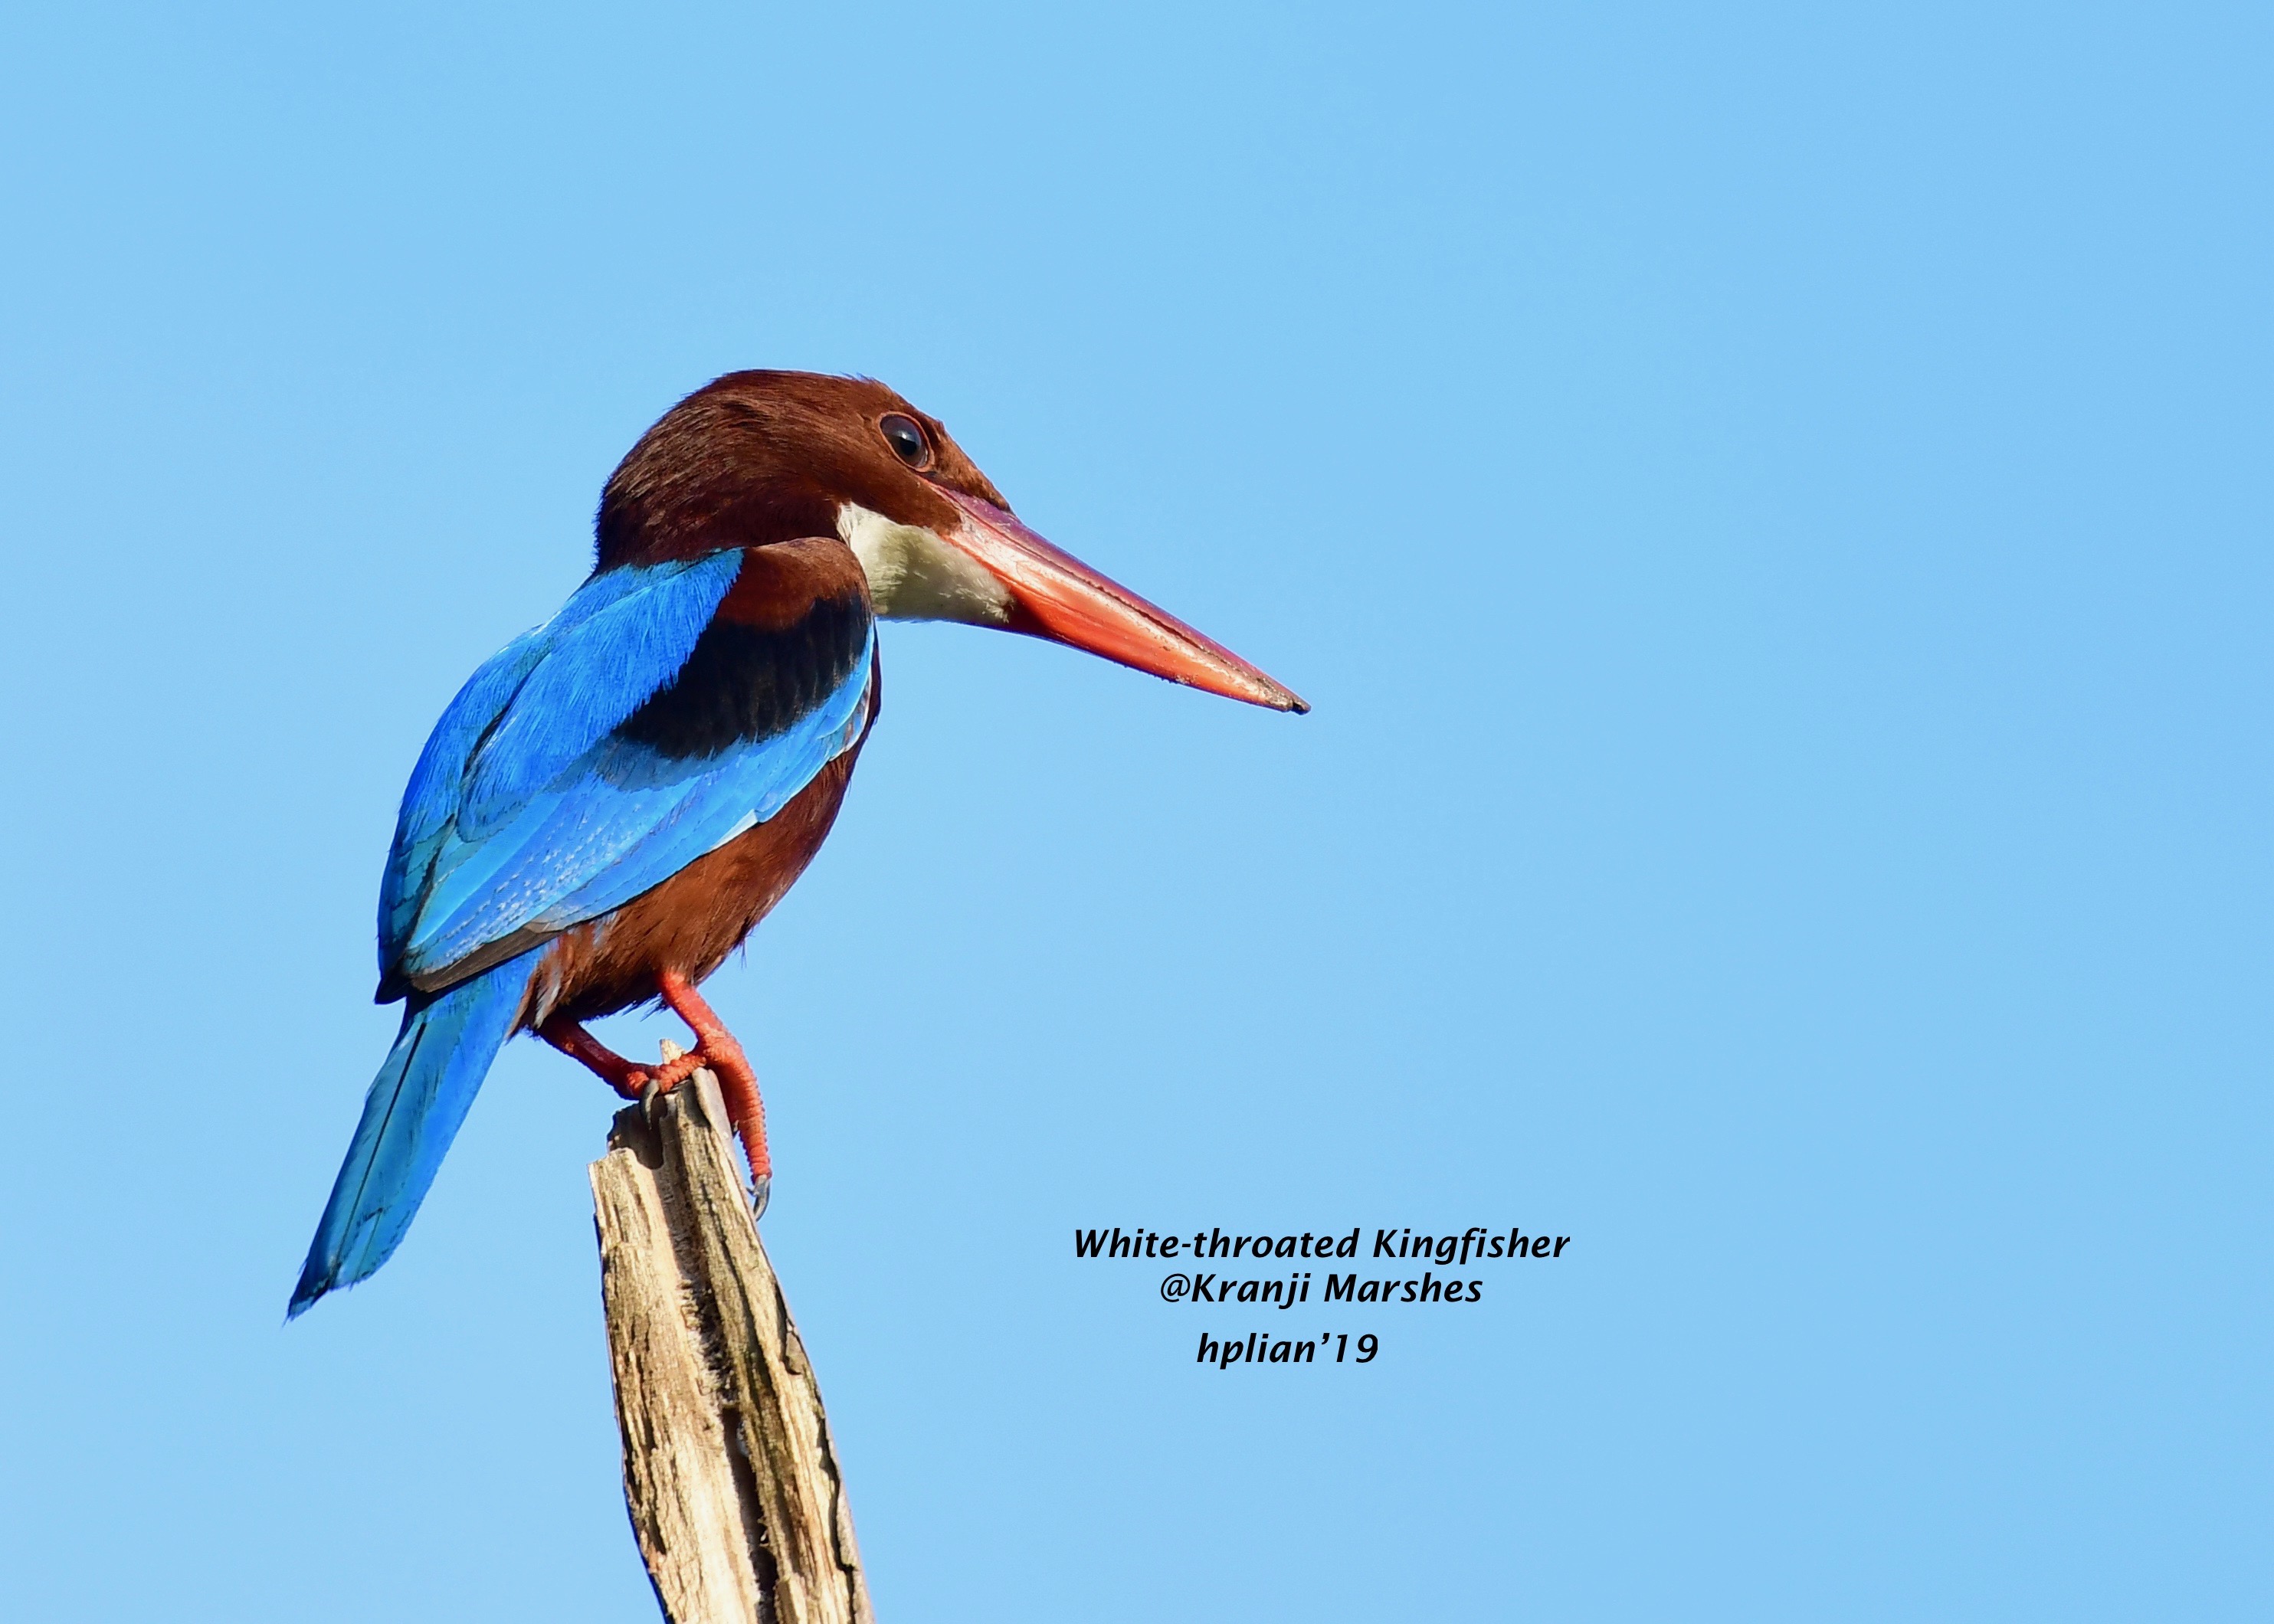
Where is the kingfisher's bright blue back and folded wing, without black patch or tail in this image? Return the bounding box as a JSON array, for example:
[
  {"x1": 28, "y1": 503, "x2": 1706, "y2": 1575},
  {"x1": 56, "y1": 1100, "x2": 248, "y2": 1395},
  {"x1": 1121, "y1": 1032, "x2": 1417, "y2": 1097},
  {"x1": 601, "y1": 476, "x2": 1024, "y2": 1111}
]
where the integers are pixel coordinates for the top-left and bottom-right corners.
[{"x1": 380, "y1": 548, "x2": 876, "y2": 997}]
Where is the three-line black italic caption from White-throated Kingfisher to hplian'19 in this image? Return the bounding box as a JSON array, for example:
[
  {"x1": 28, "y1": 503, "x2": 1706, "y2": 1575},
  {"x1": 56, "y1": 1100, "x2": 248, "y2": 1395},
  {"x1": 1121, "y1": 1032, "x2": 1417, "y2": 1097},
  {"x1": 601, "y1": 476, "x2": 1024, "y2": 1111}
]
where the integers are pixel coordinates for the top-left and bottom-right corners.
[{"x1": 1073, "y1": 1223, "x2": 1571, "y2": 1369}]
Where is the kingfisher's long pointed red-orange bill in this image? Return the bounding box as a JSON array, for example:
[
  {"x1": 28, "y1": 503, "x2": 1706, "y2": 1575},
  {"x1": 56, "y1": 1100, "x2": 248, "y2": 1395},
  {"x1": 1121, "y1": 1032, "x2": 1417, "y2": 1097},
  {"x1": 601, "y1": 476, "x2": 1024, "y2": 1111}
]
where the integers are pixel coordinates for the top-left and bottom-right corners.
[{"x1": 935, "y1": 486, "x2": 1310, "y2": 712}]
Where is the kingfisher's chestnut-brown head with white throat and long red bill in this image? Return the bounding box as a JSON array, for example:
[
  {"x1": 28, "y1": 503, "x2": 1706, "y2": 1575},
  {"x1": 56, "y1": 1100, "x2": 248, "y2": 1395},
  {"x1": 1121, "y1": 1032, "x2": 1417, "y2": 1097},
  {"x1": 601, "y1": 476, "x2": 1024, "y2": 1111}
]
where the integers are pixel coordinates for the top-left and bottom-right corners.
[{"x1": 598, "y1": 373, "x2": 1310, "y2": 712}]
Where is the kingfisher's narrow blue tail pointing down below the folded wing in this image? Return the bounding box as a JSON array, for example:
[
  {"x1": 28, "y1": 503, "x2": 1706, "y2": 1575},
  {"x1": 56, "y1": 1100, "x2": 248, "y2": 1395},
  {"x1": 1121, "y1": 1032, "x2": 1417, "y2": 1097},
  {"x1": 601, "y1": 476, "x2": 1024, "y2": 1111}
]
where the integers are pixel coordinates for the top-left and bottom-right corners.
[{"x1": 287, "y1": 948, "x2": 543, "y2": 1319}]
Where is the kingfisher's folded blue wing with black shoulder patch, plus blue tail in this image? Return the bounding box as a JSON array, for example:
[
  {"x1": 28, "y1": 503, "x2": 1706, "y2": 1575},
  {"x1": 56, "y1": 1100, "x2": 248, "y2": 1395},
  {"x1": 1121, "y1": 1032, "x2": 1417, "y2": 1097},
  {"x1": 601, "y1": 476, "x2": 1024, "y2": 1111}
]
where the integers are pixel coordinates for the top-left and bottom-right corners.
[{"x1": 291, "y1": 548, "x2": 876, "y2": 1315}]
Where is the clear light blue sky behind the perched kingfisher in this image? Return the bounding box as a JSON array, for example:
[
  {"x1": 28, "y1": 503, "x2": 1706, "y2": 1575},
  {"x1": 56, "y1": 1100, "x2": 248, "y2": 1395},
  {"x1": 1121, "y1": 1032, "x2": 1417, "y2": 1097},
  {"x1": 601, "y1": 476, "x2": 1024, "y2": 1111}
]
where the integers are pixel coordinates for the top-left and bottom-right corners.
[{"x1": 0, "y1": 5, "x2": 2274, "y2": 1624}]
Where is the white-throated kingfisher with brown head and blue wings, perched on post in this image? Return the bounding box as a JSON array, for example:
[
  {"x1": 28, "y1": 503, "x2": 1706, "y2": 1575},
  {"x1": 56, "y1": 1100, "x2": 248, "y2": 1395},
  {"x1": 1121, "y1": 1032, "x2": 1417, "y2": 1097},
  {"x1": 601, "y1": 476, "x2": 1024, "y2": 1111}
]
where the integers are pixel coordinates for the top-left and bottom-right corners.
[{"x1": 287, "y1": 371, "x2": 1310, "y2": 1319}]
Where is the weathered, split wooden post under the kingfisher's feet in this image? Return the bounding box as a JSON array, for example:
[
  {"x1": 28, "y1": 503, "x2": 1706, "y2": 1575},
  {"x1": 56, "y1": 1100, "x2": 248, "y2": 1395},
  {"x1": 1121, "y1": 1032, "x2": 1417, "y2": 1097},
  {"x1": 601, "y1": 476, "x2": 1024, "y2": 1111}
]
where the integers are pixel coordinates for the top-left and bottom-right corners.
[{"x1": 591, "y1": 1044, "x2": 876, "y2": 1624}]
